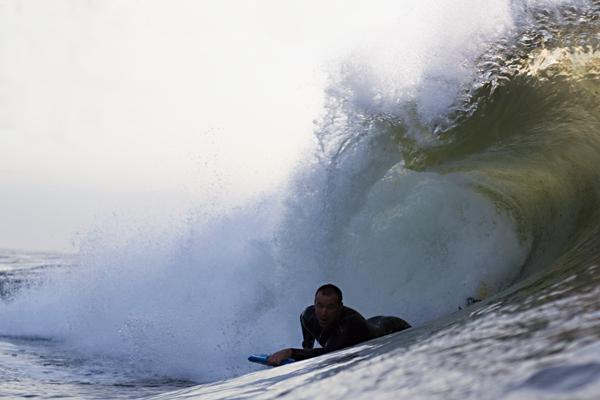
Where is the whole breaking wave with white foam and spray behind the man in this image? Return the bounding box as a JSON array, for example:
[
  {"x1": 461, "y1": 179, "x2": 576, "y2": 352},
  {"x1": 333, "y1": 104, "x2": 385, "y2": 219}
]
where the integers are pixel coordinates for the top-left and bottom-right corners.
[{"x1": 0, "y1": 2, "x2": 600, "y2": 388}]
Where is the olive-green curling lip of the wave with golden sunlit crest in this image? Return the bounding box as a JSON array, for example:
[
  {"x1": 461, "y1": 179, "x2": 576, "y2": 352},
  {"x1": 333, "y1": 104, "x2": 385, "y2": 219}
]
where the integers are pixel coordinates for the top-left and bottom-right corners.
[{"x1": 412, "y1": 4, "x2": 600, "y2": 277}]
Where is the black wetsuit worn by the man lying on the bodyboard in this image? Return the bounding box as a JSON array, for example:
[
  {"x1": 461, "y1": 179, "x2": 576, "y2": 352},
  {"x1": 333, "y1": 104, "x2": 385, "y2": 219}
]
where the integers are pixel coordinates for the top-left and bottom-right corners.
[{"x1": 292, "y1": 306, "x2": 410, "y2": 361}]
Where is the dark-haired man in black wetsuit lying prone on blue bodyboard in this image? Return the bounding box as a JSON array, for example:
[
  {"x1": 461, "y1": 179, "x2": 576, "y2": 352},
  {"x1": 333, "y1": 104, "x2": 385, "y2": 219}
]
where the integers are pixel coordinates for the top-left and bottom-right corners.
[{"x1": 267, "y1": 284, "x2": 410, "y2": 365}]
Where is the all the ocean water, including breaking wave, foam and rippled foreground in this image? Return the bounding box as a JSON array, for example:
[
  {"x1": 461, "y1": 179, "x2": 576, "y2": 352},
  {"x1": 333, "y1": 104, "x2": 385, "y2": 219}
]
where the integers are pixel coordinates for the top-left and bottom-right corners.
[{"x1": 0, "y1": 1, "x2": 600, "y2": 399}]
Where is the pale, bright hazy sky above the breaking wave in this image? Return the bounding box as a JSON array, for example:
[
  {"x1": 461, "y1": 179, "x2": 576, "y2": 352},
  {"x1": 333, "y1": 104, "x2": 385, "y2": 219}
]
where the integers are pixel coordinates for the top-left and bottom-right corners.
[{"x1": 0, "y1": 0, "x2": 399, "y2": 251}]
